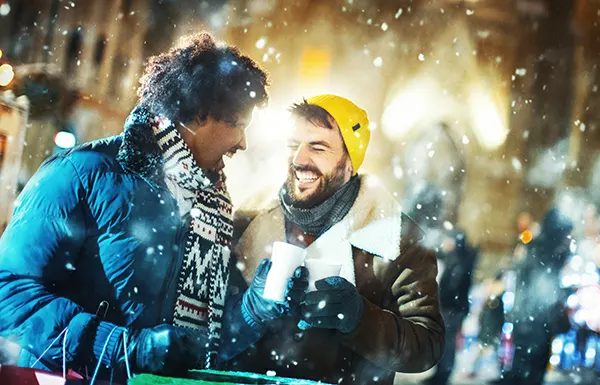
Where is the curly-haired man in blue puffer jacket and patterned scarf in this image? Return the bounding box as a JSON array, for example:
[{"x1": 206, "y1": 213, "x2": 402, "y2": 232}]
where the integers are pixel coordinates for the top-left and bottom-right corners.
[{"x1": 0, "y1": 33, "x2": 306, "y2": 378}]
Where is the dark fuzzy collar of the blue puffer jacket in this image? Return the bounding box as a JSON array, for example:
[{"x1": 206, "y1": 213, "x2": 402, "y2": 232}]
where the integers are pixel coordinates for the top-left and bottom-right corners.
[{"x1": 117, "y1": 106, "x2": 164, "y2": 184}]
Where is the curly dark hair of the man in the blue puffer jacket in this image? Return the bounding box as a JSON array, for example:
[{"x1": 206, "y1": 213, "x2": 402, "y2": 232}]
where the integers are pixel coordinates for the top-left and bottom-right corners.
[{"x1": 137, "y1": 32, "x2": 269, "y2": 123}]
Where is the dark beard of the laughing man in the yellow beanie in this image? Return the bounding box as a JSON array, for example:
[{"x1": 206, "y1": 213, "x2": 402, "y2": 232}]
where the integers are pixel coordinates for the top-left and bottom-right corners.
[{"x1": 286, "y1": 157, "x2": 346, "y2": 209}]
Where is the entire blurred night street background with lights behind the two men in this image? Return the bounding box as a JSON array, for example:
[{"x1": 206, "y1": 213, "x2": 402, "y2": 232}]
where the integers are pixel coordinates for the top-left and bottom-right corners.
[{"x1": 0, "y1": 0, "x2": 600, "y2": 383}]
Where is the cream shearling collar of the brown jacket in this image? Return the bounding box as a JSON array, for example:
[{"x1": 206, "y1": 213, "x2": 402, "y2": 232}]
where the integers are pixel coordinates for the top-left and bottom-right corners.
[{"x1": 236, "y1": 176, "x2": 404, "y2": 283}]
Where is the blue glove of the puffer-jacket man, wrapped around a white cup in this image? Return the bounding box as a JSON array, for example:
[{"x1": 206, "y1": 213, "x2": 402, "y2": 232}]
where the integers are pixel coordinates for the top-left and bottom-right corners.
[{"x1": 242, "y1": 259, "x2": 308, "y2": 327}]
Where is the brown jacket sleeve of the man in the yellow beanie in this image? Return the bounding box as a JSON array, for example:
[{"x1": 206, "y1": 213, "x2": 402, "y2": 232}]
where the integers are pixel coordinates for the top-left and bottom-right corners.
[{"x1": 343, "y1": 222, "x2": 445, "y2": 373}]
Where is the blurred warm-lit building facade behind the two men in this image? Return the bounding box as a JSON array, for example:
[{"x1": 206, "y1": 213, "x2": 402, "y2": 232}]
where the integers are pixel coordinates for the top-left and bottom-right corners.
[{"x1": 0, "y1": 0, "x2": 600, "y2": 270}]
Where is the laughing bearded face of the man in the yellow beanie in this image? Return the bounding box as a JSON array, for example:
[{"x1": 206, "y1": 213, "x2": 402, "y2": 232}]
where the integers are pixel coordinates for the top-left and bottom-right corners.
[{"x1": 287, "y1": 117, "x2": 352, "y2": 208}]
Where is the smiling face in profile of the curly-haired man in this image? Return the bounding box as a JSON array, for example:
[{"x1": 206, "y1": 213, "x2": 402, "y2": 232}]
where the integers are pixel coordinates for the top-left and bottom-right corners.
[{"x1": 178, "y1": 111, "x2": 252, "y2": 172}]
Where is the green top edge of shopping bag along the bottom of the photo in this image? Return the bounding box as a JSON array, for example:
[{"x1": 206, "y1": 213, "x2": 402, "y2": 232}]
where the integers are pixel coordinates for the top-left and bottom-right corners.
[{"x1": 129, "y1": 370, "x2": 328, "y2": 385}]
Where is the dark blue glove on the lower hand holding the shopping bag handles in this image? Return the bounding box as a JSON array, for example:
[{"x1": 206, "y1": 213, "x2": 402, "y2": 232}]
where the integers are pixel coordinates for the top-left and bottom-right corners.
[{"x1": 114, "y1": 324, "x2": 208, "y2": 377}]
